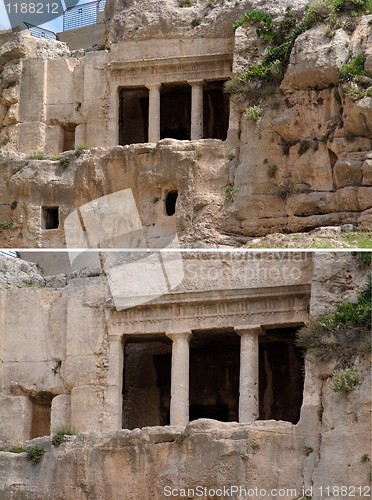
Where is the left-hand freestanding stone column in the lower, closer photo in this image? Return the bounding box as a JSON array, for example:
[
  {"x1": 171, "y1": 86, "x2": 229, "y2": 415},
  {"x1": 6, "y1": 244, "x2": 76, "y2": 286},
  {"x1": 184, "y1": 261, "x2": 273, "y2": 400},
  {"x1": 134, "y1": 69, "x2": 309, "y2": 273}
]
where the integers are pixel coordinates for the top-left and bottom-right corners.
[{"x1": 167, "y1": 332, "x2": 191, "y2": 426}]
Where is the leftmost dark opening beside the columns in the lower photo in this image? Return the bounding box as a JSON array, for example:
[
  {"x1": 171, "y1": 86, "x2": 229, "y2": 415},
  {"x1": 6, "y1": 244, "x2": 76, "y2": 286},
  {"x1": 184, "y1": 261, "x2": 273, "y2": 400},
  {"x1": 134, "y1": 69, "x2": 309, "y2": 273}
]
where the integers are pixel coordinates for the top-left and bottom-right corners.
[{"x1": 123, "y1": 335, "x2": 172, "y2": 429}]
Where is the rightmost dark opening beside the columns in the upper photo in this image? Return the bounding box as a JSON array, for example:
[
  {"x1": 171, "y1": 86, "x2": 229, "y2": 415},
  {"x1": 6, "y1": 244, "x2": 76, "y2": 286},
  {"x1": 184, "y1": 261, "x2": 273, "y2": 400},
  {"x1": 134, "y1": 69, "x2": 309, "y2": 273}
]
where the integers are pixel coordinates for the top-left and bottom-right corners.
[{"x1": 203, "y1": 81, "x2": 229, "y2": 141}]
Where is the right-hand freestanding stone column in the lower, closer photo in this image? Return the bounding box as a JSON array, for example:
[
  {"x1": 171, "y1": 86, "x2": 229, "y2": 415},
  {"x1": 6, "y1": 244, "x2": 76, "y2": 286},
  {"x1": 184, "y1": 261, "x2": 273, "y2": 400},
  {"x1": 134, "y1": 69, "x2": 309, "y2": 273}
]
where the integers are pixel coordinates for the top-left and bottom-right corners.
[{"x1": 235, "y1": 325, "x2": 262, "y2": 423}]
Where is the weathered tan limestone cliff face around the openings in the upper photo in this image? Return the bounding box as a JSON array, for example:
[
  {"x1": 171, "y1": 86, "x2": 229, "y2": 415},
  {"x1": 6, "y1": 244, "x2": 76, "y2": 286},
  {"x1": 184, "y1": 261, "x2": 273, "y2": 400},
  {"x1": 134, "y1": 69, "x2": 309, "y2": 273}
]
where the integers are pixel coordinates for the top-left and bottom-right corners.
[{"x1": 0, "y1": 1, "x2": 372, "y2": 247}]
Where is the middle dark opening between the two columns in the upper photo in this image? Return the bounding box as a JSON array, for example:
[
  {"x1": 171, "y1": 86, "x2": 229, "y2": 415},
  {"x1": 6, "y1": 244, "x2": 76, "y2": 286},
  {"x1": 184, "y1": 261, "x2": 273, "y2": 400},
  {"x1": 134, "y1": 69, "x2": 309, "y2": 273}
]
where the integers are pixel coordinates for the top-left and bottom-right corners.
[{"x1": 160, "y1": 84, "x2": 191, "y2": 140}]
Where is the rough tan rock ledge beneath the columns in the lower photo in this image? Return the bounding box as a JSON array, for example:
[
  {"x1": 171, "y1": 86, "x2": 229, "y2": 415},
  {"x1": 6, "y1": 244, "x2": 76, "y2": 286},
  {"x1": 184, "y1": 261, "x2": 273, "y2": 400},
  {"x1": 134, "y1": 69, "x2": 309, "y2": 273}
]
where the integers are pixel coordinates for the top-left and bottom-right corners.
[{"x1": 0, "y1": 348, "x2": 371, "y2": 500}]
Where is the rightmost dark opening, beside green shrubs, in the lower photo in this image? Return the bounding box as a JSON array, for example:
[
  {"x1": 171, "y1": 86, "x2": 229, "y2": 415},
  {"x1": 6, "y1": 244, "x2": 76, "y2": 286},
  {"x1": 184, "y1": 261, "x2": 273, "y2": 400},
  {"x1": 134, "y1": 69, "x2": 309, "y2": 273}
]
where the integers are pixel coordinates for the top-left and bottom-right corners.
[{"x1": 259, "y1": 328, "x2": 304, "y2": 424}]
